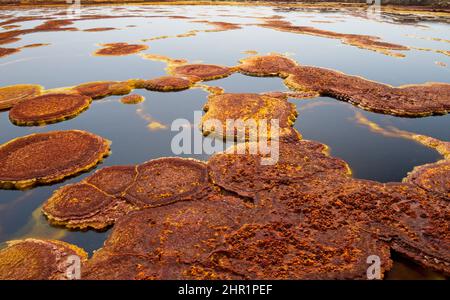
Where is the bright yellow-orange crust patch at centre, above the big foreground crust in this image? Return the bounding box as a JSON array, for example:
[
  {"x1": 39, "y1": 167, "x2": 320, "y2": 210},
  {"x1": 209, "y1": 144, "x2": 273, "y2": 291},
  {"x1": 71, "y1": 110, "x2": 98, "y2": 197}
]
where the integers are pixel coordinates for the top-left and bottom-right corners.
[{"x1": 202, "y1": 94, "x2": 297, "y2": 139}]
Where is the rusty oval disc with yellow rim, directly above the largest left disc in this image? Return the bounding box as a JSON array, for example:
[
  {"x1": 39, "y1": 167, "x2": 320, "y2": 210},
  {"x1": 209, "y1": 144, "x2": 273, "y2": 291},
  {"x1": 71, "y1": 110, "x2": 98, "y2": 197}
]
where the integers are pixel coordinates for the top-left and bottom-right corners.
[{"x1": 9, "y1": 94, "x2": 92, "y2": 126}]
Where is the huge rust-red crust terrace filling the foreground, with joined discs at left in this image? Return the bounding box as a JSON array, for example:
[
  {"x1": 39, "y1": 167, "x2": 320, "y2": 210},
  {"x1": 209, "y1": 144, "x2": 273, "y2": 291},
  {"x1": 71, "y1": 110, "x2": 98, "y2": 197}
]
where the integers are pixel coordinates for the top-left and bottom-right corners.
[{"x1": 35, "y1": 131, "x2": 450, "y2": 279}]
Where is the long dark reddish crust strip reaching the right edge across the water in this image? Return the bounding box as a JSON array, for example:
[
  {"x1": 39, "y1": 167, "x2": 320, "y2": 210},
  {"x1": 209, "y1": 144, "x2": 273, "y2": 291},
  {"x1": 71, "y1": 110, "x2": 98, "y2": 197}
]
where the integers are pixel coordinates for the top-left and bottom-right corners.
[{"x1": 285, "y1": 66, "x2": 450, "y2": 117}]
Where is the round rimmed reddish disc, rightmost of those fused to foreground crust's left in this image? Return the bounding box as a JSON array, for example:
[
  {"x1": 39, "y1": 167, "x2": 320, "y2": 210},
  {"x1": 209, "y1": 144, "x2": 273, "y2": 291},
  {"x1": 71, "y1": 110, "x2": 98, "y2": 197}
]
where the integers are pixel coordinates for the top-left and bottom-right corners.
[{"x1": 124, "y1": 158, "x2": 208, "y2": 207}]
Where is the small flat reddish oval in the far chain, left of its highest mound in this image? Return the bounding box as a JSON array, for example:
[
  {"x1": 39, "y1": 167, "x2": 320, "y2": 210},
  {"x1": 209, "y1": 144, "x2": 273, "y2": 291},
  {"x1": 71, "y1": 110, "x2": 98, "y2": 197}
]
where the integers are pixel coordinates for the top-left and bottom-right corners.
[{"x1": 171, "y1": 64, "x2": 234, "y2": 81}]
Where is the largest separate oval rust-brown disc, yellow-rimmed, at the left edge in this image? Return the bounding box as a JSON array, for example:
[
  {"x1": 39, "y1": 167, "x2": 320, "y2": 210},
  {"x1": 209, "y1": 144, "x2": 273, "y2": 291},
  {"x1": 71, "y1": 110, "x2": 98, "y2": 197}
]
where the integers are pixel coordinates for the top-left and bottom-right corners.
[{"x1": 0, "y1": 130, "x2": 109, "y2": 189}]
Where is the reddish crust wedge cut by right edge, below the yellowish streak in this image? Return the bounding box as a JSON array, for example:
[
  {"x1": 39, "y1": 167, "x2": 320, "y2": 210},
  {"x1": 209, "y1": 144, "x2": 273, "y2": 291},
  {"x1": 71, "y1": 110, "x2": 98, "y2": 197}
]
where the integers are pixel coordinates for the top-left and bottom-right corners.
[{"x1": 404, "y1": 160, "x2": 450, "y2": 199}]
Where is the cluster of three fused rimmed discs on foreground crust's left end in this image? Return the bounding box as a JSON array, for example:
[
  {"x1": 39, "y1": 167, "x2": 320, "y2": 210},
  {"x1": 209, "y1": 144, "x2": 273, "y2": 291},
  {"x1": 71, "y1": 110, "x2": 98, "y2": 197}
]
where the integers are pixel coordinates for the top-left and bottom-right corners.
[{"x1": 42, "y1": 158, "x2": 210, "y2": 230}]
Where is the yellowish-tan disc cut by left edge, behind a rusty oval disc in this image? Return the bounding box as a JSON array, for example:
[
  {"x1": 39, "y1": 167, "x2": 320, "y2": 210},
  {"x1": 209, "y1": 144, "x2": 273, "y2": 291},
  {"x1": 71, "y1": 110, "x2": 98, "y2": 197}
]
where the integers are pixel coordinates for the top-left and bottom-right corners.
[{"x1": 0, "y1": 84, "x2": 42, "y2": 111}]
